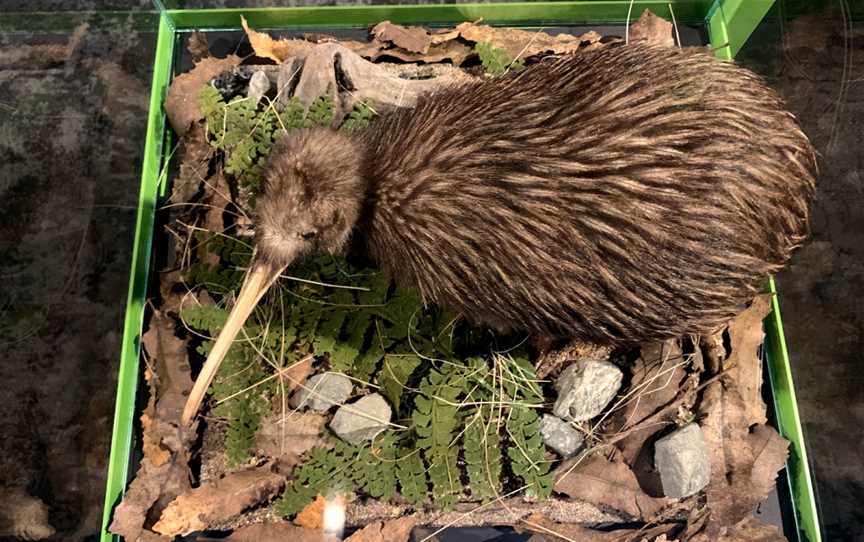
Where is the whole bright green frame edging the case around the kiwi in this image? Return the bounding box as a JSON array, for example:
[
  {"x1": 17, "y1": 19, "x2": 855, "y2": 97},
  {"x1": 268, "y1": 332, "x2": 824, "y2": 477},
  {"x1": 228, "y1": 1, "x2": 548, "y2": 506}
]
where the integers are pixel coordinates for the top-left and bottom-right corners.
[{"x1": 100, "y1": 0, "x2": 822, "y2": 542}]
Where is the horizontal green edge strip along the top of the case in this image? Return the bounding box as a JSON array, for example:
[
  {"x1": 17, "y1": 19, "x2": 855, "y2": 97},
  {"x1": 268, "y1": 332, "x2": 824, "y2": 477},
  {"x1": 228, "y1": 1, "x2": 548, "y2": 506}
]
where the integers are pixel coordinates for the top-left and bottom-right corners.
[{"x1": 166, "y1": 0, "x2": 711, "y2": 31}]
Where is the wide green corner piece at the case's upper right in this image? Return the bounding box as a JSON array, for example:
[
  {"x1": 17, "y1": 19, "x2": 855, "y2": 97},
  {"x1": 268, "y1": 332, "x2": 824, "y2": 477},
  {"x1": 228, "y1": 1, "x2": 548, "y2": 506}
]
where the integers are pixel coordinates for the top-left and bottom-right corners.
[{"x1": 705, "y1": 0, "x2": 774, "y2": 60}]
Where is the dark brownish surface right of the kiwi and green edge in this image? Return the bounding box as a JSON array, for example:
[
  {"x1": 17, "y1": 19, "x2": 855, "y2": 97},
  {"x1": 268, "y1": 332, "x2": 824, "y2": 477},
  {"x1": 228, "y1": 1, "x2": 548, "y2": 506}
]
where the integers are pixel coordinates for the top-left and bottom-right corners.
[{"x1": 738, "y1": 4, "x2": 864, "y2": 540}]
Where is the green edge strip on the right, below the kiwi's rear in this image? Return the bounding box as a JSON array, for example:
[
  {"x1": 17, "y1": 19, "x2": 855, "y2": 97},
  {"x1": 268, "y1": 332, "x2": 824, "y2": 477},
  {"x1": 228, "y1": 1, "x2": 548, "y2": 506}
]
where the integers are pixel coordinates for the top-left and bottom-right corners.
[{"x1": 764, "y1": 278, "x2": 822, "y2": 542}]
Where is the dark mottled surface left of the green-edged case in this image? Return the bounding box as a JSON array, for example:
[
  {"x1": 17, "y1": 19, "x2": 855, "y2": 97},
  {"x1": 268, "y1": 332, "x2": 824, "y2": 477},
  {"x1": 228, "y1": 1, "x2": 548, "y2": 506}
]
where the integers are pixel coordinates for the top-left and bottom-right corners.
[{"x1": 0, "y1": 5, "x2": 157, "y2": 540}]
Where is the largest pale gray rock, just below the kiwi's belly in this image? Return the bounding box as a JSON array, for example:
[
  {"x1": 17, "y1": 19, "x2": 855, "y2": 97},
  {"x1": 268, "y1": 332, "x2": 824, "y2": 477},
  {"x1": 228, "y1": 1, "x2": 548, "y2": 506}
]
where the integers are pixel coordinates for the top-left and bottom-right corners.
[{"x1": 552, "y1": 359, "x2": 624, "y2": 422}]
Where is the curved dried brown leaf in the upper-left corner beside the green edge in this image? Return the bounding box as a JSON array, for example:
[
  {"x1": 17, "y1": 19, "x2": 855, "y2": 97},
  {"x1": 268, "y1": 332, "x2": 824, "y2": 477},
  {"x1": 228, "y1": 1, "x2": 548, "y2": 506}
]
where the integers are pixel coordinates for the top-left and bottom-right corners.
[{"x1": 165, "y1": 55, "x2": 240, "y2": 136}]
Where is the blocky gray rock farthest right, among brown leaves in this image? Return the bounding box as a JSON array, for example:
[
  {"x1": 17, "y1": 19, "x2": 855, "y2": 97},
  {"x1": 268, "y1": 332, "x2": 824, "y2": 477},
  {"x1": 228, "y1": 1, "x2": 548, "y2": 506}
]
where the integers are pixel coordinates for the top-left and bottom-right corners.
[{"x1": 654, "y1": 423, "x2": 711, "y2": 499}]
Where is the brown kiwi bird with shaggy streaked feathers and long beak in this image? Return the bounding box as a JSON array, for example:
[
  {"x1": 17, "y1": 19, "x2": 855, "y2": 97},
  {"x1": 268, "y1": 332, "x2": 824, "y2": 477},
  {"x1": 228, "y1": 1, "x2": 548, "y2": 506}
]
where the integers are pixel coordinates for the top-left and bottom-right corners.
[{"x1": 179, "y1": 45, "x2": 817, "y2": 428}]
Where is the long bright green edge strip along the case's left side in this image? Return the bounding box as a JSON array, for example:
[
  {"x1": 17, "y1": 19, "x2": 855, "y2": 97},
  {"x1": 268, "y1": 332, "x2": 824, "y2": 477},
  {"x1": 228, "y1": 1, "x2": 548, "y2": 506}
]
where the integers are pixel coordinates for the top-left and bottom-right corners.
[{"x1": 100, "y1": 12, "x2": 174, "y2": 542}]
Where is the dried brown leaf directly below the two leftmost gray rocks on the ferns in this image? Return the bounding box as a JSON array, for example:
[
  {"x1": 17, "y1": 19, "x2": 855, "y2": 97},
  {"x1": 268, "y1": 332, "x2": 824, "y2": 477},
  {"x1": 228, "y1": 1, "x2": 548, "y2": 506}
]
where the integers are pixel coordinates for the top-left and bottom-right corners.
[{"x1": 255, "y1": 412, "x2": 327, "y2": 457}]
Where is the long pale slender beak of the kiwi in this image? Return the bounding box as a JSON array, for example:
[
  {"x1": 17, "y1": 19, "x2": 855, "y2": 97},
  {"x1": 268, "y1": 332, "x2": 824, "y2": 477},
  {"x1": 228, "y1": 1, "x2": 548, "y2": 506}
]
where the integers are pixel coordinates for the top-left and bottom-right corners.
[{"x1": 180, "y1": 258, "x2": 287, "y2": 427}]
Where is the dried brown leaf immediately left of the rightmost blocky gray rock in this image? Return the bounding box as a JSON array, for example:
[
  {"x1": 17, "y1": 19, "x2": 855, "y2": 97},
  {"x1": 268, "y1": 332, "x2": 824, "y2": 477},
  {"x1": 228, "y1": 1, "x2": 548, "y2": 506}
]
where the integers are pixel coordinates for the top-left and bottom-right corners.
[{"x1": 553, "y1": 453, "x2": 673, "y2": 520}]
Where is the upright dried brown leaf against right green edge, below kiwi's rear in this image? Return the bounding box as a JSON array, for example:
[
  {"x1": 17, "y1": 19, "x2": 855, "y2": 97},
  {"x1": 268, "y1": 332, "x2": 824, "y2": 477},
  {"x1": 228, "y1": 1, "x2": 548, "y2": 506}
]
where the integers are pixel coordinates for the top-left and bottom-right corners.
[{"x1": 725, "y1": 294, "x2": 771, "y2": 425}]
